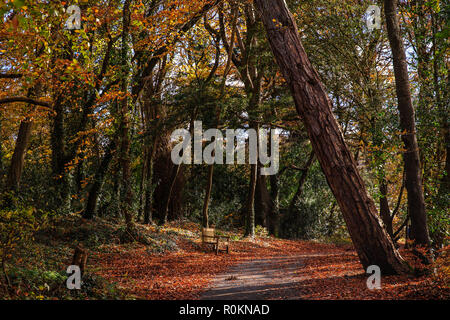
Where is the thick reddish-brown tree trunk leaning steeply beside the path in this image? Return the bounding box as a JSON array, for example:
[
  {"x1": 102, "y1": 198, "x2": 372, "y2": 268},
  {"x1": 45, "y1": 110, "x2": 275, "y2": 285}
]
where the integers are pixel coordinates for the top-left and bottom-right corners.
[{"x1": 254, "y1": 0, "x2": 409, "y2": 274}]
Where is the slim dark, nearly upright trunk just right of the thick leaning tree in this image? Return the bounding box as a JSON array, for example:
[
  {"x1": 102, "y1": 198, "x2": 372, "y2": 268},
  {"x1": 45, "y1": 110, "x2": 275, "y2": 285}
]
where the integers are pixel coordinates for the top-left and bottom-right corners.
[{"x1": 384, "y1": 0, "x2": 430, "y2": 246}]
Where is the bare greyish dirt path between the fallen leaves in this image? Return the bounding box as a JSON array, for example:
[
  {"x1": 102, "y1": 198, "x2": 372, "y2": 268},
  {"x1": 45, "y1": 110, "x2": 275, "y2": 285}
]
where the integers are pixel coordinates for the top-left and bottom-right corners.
[{"x1": 200, "y1": 256, "x2": 304, "y2": 300}]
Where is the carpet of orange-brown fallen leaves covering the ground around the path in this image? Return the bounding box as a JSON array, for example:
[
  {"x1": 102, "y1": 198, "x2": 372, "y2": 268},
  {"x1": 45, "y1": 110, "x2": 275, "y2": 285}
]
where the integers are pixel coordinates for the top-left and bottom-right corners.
[{"x1": 91, "y1": 222, "x2": 450, "y2": 300}]
